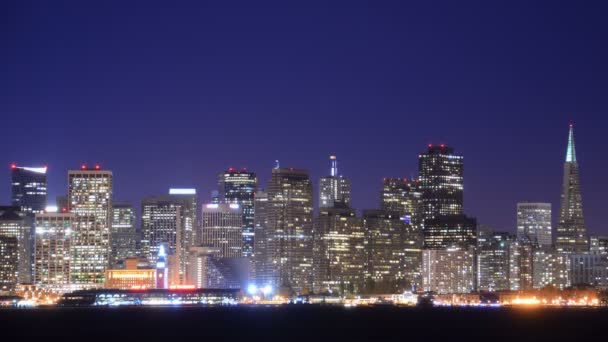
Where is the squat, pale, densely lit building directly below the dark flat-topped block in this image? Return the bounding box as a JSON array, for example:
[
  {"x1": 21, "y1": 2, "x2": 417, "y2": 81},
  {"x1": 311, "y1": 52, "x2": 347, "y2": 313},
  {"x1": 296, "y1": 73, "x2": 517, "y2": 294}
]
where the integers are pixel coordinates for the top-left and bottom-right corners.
[{"x1": 422, "y1": 247, "x2": 476, "y2": 294}]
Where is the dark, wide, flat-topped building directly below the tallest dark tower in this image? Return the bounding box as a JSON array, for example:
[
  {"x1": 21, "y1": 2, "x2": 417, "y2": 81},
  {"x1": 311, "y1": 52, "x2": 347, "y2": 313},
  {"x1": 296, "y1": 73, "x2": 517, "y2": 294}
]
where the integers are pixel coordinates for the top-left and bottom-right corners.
[{"x1": 423, "y1": 215, "x2": 477, "y2": 249}]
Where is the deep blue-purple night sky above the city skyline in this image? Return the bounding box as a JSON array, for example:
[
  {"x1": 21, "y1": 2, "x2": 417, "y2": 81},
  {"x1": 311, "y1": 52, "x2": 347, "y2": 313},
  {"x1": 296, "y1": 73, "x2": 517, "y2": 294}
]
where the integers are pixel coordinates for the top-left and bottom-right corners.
[{"x1": 0, "y1": 1, "x2": 608, "y2": 234}]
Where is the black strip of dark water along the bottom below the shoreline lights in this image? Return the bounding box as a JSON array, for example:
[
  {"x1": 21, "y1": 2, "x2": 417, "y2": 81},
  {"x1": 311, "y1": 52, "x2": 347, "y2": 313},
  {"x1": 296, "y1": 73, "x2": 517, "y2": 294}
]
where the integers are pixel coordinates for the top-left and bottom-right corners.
[{"x1": 0, "y1": 305, "x2": 608, "y2": 342}]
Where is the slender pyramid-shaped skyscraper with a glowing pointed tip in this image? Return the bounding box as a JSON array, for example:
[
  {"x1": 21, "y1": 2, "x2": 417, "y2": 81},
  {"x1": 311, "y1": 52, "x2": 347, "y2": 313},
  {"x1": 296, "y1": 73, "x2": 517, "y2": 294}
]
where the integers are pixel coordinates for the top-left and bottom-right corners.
[{"x1": 555, "y1": 125, "x2": 589, "y2": 253}]
